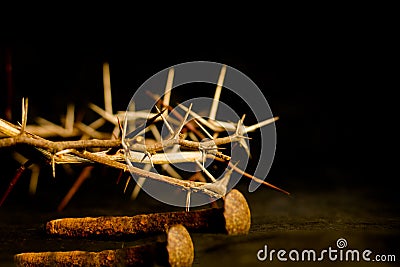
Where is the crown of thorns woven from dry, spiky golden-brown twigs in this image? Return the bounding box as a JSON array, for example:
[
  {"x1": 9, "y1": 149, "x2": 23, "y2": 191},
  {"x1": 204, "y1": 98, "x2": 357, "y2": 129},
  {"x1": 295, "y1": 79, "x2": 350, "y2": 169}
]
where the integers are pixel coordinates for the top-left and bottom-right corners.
[{"x1": 0, "y1": 62, "x2": 289, "y2": 211}]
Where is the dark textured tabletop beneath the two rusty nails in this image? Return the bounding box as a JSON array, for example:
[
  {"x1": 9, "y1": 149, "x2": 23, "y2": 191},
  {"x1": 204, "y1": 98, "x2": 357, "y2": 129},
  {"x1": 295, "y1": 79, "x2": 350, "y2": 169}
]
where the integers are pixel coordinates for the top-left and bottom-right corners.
[{"x1": 0, "y1": 183, "x2": 400, "y2": 266}]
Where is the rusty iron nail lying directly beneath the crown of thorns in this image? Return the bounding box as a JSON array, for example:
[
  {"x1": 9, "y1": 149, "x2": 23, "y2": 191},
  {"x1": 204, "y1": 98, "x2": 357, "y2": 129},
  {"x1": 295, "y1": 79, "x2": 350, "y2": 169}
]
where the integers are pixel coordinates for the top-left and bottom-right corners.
[{"x1": 46, "y1": 189, "x2": 251, "y2": 238}]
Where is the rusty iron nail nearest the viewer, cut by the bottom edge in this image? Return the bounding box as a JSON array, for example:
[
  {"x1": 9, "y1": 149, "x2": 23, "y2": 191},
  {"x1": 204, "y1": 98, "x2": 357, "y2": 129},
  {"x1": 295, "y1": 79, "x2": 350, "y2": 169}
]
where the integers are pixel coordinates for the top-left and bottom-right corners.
[{"x1": 14, "y1": 225, "x2": 194, "y2": 267}]
